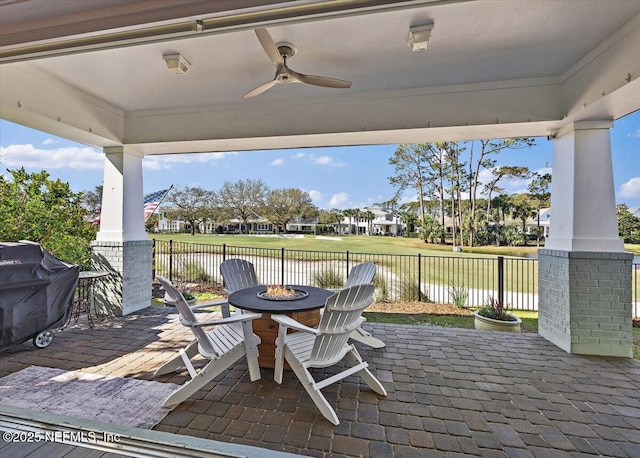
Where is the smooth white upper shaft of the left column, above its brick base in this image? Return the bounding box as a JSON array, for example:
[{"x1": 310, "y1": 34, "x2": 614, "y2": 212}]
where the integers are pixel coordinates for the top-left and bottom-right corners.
[{"x1": 96, "y1": 146, "x2": 148, "y2": 242}]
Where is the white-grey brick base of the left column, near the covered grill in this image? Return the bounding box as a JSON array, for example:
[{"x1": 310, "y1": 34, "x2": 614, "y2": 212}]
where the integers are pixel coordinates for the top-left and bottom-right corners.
[{"x1": 91, "y1": 240, "x2": 153, "y2": 316}]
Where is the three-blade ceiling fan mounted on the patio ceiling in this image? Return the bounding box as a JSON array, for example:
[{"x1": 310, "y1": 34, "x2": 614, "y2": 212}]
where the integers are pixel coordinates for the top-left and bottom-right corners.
[{"x1": 242, "y1": 29, "x2": 351, "y2": 99}]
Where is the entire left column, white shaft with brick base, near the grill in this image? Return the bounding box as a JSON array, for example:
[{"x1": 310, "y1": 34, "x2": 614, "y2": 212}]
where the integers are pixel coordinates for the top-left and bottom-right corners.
[{"x1": 91, "y1": 147, "x2": 153, "y2": 315}]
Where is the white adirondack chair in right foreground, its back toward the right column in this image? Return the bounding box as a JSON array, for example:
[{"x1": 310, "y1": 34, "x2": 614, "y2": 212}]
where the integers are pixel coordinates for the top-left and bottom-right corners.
[{"x1": 271, "y1": 285, "x2": 387, "y2": 425}]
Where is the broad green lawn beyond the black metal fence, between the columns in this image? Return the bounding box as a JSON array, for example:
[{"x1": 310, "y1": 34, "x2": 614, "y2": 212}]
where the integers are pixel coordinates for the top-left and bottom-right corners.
[{"x1": 155, "y1": 234, "x2": 538, "y2": 294}]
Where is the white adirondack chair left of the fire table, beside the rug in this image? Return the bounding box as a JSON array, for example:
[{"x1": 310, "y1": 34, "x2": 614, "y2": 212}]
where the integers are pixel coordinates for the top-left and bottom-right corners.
[{"x1": 154, "y1": 276, "x2": 261, "y2": 407}]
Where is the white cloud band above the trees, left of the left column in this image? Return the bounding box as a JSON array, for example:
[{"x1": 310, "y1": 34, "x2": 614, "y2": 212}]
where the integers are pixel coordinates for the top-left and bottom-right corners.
[{"x1": 0, "y1": 144, "x2": 104, "y2": 170}]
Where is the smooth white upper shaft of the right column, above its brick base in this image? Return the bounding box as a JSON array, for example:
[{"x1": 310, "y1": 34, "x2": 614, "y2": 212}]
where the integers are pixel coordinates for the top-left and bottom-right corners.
[{"x1": 545, "y1": 121, "x2": 624, "y2": 252}]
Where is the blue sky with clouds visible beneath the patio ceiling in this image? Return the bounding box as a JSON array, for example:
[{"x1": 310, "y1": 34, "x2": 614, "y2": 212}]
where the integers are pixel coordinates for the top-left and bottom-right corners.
[{"x1": 0, "y1": 111, "x2": 640, "y2": 209}]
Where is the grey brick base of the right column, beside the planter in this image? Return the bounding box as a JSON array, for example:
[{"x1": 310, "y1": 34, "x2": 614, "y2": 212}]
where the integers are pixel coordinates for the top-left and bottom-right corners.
[{"x1": 538, "y1": 249, "x2": 633, "y2": 357}]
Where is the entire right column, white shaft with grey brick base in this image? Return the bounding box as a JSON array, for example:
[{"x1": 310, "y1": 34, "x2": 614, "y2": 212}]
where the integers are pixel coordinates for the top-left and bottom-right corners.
[{"x1": 538, "y1": 121, "x2": 633, "y2": 357}]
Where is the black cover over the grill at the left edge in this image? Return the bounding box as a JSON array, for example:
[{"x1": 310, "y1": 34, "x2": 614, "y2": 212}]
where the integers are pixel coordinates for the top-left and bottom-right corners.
[{"x1": 0, "y1": 242, "x2": 80, "y2": 350}]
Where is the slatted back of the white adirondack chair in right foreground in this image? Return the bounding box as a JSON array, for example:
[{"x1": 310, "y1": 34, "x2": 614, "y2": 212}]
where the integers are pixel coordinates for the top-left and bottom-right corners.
[{"x1": 311, "y1": 284, "x2": 374, "y2": 365}]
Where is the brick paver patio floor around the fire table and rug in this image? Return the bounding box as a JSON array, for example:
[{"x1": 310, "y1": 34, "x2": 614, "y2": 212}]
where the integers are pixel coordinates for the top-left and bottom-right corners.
[{"x1": 0, "y1": 307, "x2": 640, "y2": 458}]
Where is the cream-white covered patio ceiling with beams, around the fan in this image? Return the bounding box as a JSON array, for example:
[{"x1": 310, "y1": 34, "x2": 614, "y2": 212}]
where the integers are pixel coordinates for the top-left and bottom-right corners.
[{"x1": 0, "y1": 0, "x2": 640, "y2": 155}]
